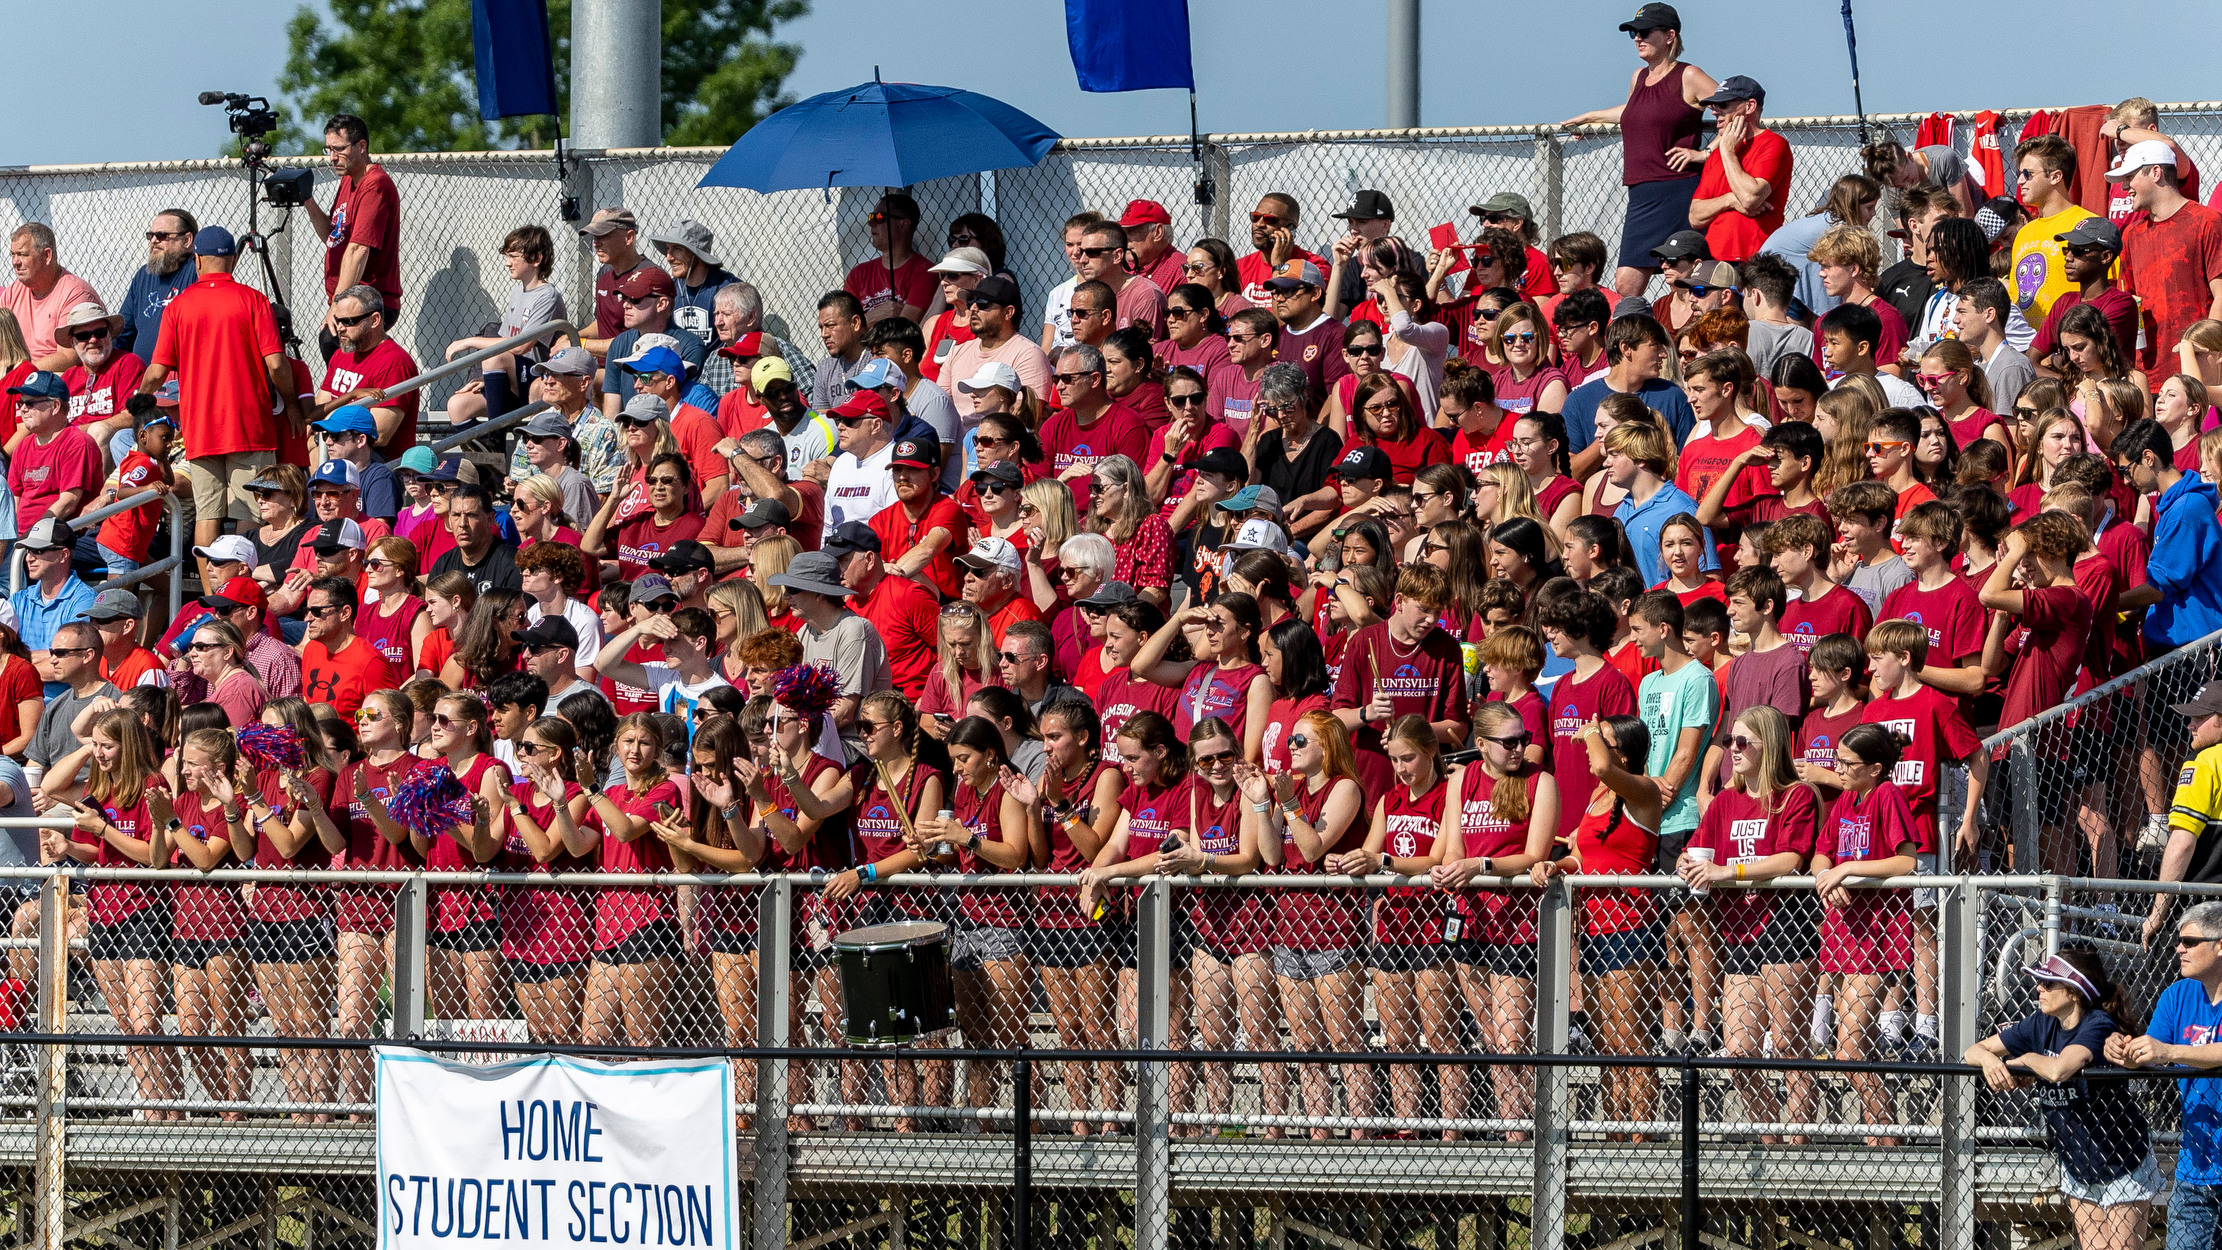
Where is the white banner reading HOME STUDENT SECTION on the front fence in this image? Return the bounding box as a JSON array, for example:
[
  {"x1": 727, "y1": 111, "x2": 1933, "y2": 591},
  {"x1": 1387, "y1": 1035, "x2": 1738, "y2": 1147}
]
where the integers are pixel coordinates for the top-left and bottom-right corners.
[{"x1": 378, "y1": 1048, "x2": 747, "y2": 1250}]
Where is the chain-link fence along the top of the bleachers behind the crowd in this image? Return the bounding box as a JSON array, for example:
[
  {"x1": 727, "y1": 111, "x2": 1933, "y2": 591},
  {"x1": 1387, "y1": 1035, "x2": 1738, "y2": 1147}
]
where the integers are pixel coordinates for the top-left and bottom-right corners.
[{"x1": 13, "y1": 102, "x2": 2222, "y2": 409}]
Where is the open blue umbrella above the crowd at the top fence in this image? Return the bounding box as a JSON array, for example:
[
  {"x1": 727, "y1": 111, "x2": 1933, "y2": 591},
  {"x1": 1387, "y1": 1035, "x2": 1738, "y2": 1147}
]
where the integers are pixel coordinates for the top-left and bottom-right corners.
[{"x1": 698, "y1": 82, "x2": 1060, "y2": 191}]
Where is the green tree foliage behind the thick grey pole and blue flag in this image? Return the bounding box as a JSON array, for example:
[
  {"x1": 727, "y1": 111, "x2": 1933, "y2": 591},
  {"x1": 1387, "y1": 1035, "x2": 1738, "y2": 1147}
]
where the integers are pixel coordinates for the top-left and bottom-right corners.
[{"x1": 278, "y1": 0, "x2": 809, "y2": 153}]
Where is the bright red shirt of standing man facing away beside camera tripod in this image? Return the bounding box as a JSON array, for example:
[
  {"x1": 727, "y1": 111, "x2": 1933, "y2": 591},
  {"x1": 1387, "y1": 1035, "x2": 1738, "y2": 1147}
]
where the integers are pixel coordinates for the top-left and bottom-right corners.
[{"x1": 149, "y1": 273, "x2": 284, "y2": 457}]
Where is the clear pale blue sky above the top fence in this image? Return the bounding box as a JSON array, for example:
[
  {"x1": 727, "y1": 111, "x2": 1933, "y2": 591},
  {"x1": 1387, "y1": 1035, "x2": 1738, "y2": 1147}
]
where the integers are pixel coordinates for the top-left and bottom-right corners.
[{"x1": 17, "y1": 0, "x2": 2222, "y2": 164}]
